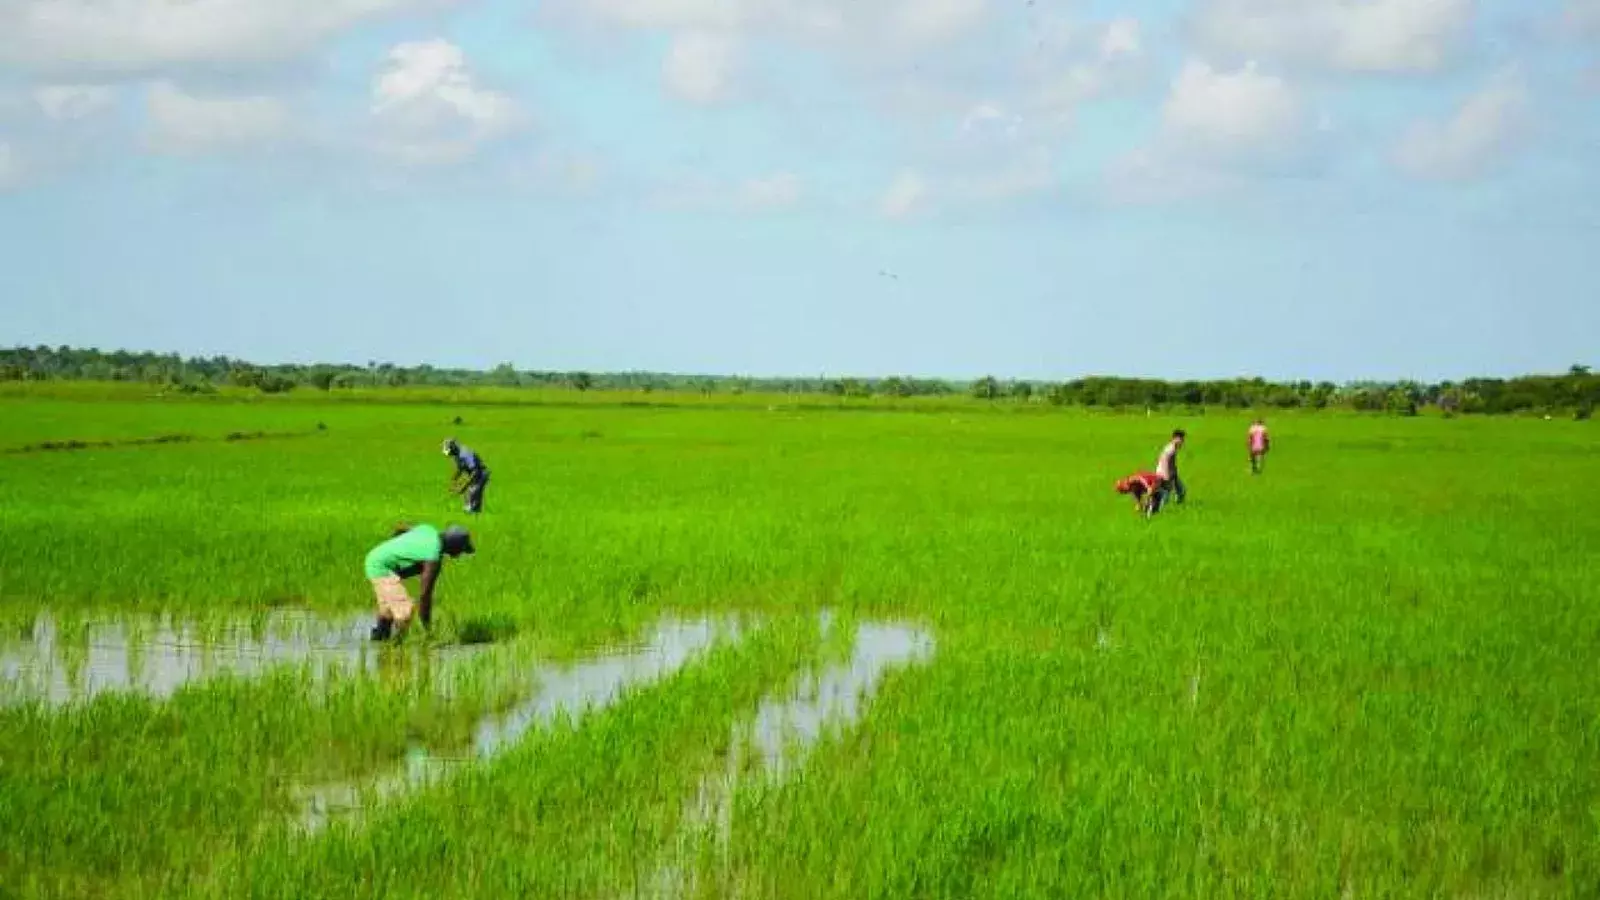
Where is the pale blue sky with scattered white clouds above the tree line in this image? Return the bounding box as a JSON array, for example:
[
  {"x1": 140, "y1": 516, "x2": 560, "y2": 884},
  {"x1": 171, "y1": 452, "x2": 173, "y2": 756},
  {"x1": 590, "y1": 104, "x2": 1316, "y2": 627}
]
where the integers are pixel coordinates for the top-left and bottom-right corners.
[{"x1": 0, "y1": 0, "x2": 1600, "y2": 380}]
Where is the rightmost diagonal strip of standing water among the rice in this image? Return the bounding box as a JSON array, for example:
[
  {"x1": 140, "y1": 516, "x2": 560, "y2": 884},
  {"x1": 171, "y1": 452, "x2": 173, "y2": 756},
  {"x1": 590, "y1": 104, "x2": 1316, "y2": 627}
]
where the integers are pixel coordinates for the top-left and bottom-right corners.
[{"x1": 640, "y1": 612, "x2": 934, "y2": 897}]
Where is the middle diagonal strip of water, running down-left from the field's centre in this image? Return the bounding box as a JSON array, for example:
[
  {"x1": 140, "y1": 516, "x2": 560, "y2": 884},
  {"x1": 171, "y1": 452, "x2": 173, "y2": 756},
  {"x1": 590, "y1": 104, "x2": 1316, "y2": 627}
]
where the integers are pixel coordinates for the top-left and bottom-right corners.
[{"x1": 299, "y1": 618, "x2": 739, "y2": 831}]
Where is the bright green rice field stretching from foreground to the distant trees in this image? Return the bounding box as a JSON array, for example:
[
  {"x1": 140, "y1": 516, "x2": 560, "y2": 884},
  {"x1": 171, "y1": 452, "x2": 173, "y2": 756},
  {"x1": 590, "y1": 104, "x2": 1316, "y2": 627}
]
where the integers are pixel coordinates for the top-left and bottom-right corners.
[{"x1": 0, "y1": 389, "x2": 1600, "y2": 900}]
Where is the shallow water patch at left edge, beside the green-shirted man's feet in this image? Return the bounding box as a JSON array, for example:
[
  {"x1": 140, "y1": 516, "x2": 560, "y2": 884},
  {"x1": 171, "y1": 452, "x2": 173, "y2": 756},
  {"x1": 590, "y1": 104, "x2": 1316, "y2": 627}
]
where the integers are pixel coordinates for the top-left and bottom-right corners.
[{"x1": 0, "y1": 610, "x2": 422, "y2": 705}]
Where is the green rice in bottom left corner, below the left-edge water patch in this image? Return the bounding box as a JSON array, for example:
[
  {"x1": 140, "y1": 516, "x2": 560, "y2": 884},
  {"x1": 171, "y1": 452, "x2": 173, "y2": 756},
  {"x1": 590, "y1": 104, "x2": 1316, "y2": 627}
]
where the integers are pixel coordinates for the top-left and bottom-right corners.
[{"x1": 0, "y1": 637, "x2": 531, "y2": 895}]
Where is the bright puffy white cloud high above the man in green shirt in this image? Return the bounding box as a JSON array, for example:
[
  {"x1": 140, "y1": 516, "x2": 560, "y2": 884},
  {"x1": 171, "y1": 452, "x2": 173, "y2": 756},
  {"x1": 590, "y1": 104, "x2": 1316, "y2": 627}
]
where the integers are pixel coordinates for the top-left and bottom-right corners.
[{"x1": 371, "y1": 40, "x2": 523, "y2": 163}]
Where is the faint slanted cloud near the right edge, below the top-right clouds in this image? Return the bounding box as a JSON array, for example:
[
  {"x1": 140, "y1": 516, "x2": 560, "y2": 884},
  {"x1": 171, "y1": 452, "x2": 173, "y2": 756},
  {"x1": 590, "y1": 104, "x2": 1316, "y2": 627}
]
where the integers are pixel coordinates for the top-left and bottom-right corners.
[{"x1": 1395, "y1": 72, "x2": 1528, "y2": 181}]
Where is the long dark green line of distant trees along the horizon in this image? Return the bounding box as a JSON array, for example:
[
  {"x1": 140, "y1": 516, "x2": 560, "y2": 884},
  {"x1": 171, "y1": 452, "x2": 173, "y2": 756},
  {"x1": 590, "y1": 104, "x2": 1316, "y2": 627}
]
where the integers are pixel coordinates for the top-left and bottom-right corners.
[{"x1": 0, "y1": 346, "x2": 1600, "y2": 418}]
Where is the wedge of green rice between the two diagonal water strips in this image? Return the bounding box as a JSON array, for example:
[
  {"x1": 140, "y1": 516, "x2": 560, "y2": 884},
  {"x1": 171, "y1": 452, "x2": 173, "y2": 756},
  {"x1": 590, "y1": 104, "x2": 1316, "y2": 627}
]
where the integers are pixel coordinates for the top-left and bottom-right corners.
[{"x1": 208, "y1": 611, "x2": 814, "y2": 897}]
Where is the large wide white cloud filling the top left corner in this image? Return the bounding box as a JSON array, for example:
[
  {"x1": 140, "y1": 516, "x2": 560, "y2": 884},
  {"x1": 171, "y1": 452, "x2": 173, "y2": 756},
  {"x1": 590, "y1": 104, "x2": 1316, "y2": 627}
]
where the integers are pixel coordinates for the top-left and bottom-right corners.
[{"x1": 0, "y1": 0, "x2": 450, "y2": 74}]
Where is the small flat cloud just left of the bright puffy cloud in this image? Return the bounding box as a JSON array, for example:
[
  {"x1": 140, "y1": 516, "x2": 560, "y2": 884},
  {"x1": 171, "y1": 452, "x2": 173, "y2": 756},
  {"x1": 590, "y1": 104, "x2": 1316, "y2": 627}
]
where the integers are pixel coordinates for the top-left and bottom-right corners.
[{"x1": 144, "y1": 82, "x2": 291, "y2": 154}]
